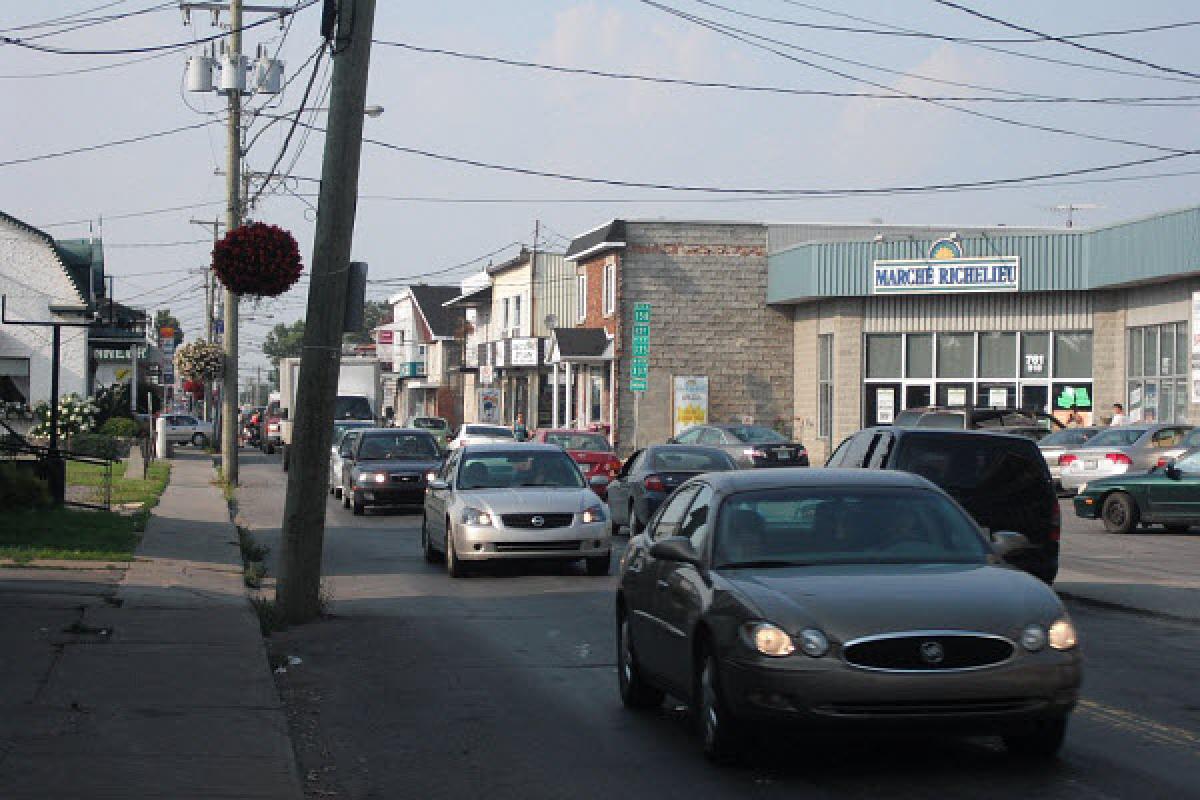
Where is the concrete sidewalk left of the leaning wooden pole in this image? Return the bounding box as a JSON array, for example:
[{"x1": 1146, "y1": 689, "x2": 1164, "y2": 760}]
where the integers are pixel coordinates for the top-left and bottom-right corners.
[{"x1": 0, "y1": 453, "x2": 302, "y2": 800}]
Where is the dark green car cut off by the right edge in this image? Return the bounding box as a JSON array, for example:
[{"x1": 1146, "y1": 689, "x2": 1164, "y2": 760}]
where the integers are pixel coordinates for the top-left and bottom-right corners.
[{"x1": 1075, "y1": 447, "x2": 1200, "y2": 534}]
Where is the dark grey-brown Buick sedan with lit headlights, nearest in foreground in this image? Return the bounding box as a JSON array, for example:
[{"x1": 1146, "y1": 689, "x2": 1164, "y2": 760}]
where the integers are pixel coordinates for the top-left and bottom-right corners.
[{"x1": 617, "y1": 470, "x2": 1082, "y2": 759}]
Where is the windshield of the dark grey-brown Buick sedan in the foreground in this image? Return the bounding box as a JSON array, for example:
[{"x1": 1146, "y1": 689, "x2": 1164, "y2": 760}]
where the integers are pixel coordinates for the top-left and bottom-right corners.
[{"x1": 713, "y1": 488, "x2": 988, "y2": 567}]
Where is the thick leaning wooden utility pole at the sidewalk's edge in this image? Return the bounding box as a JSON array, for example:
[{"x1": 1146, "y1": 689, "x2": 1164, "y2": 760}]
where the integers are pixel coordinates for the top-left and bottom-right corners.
[{"x1": 277, "y1": 0, "x2": 376, "y2": 624}]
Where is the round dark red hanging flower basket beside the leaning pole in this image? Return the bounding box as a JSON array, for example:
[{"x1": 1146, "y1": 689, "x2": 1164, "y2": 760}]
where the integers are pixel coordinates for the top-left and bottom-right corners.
[{"x1": 212, "y1": 222, "x2": 304, "y2": 297}]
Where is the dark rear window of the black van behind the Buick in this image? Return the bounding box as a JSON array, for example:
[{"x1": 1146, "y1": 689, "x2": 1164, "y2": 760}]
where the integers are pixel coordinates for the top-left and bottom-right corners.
[{"x1": 895, "y1": 435, "x2": 1049, "y2": 493}]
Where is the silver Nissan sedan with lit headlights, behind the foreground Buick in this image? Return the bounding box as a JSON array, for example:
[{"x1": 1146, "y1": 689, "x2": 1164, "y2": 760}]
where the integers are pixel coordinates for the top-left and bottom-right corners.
[{"x1": 421, "y1": 441, "x2": 612, "y2": 578}]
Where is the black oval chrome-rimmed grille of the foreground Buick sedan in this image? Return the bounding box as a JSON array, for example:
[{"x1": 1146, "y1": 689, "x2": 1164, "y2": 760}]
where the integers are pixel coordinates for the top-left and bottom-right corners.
[{"x1": 842, "y1": 632, "x2": 1016, "y2": 672}]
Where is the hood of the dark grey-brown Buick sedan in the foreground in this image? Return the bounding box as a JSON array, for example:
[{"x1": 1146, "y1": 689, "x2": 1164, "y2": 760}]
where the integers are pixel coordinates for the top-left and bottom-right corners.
[{"x1": 719, "y1": 564, "x2": 1064, "y2": 642}]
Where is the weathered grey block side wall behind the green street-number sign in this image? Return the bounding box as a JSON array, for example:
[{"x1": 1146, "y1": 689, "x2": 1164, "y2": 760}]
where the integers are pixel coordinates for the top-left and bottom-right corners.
[{"x1": 618, "y1": 222, "x2": 794, "y2": 453}]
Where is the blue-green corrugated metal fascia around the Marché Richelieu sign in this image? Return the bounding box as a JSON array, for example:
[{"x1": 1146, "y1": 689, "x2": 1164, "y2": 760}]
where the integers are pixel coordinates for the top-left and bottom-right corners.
[{"x1": 767, "y1": 207, "x2": 1200, "y2": 303}]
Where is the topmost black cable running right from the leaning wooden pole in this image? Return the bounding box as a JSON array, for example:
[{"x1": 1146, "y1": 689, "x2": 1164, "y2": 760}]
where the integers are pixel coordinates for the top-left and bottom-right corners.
[{"x1": 374, "y1": 38, "x2": 1200, "y2": 108}]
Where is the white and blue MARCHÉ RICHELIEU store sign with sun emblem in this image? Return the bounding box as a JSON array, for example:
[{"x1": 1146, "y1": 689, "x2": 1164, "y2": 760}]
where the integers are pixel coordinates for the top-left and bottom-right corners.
[{"x1": 871, "y1": 239, "x2": 1020, "y2": 294}]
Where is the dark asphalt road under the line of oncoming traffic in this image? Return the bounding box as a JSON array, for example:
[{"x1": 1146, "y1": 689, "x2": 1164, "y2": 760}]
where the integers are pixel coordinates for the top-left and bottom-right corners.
[{"x1": 239, "y1": 456, "x2": 1200, "y2": 800}]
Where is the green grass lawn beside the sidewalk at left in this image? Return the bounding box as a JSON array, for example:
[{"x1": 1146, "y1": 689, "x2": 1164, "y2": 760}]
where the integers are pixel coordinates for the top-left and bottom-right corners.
[{"x1": 0, "y1": 462, "x2": 170, "y2": 561}]
